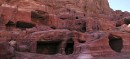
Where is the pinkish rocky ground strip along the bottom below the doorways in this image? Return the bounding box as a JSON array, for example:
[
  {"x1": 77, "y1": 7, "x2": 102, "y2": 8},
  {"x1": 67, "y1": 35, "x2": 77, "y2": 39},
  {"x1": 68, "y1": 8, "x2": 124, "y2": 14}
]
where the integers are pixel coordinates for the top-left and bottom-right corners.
[{"x1": 13, "y1": 52, "x2": 130, "y2": 59}]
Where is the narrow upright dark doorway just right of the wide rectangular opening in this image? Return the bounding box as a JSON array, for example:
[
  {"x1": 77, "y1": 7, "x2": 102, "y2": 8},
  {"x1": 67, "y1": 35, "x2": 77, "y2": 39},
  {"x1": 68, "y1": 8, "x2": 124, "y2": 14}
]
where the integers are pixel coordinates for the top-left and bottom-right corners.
[{"x1": 65, "y1": 39, "x2": 74, "y2": 55}]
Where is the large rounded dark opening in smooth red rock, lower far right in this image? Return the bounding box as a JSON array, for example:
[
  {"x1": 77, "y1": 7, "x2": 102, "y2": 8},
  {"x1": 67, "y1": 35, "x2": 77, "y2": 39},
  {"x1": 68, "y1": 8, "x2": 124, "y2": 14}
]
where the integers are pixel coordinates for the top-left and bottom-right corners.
[{"x1": 109, "y1": 34, "x2": 123, "y2": 52}]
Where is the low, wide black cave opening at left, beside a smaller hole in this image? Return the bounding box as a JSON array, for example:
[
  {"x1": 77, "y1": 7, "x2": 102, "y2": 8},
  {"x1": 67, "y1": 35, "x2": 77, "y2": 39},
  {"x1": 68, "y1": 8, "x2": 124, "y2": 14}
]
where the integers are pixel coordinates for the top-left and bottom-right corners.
[{"x1": 16, "y1": 21, "x2": 35, "y2": 28}]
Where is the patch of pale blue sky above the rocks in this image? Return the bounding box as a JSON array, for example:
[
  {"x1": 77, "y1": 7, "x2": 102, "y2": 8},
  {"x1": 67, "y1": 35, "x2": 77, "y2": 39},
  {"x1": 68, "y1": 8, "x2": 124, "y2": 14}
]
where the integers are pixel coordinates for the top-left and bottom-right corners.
[{"x1": 108, "y1": 0, "x2": 130, "y2": 12}]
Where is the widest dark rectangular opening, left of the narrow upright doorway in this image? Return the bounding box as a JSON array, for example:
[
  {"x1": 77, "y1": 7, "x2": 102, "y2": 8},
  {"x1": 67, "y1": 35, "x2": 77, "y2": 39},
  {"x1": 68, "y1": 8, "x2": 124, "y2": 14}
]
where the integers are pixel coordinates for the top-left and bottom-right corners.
[{"x1": 37, "y1": 41, "x2": 60, "y2": 55}]
